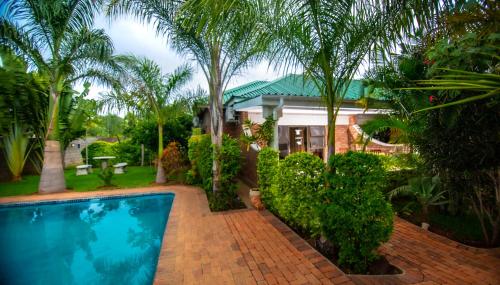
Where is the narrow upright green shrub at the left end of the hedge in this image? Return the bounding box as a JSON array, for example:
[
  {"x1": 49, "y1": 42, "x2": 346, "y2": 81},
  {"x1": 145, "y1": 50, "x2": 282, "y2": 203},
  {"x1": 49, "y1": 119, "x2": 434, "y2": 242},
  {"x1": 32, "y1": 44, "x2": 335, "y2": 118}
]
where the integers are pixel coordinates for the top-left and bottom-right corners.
[{"x1": 257, "y1": 147, "x2": 279, "y2": 209}]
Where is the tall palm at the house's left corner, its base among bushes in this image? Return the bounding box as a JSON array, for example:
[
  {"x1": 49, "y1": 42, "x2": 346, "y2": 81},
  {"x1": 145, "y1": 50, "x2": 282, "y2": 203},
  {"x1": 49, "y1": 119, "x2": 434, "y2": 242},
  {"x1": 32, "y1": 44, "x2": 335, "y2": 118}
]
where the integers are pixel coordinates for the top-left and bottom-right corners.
[{"x1": 108, "y1": 0, "x2": 266, "y2": 191}]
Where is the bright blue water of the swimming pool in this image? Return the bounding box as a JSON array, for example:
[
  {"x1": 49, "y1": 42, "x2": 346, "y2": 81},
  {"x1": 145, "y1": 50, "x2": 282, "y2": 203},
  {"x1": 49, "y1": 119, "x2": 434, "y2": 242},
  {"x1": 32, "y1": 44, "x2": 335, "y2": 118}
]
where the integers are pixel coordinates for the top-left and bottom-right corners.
[{"x1": 0, "y1": 194, "x2": 174, "y2": 285}]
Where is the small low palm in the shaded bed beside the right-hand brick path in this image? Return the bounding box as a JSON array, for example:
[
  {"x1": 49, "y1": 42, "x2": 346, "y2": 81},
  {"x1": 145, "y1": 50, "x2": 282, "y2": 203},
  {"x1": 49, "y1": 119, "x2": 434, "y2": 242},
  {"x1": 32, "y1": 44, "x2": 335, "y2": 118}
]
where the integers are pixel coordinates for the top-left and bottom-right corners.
[{"x1": 389, "y1": 176, "x2": 448, "y2": 223}]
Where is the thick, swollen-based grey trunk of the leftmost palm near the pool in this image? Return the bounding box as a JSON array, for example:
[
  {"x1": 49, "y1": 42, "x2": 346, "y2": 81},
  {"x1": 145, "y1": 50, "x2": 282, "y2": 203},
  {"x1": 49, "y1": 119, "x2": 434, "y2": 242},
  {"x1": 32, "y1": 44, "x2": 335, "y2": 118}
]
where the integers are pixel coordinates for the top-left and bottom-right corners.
[{"x1": 38, "y1": 87, "x2": 66, "y2": 193}]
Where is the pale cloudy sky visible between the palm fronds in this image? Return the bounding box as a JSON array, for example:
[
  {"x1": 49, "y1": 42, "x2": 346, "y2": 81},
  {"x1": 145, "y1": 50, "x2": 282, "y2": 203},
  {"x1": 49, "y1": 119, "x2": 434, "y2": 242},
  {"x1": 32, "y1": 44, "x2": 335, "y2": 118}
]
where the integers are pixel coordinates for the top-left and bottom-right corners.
[{"x1": 82, "y1": 16, "x2": 281, "y2": 98}]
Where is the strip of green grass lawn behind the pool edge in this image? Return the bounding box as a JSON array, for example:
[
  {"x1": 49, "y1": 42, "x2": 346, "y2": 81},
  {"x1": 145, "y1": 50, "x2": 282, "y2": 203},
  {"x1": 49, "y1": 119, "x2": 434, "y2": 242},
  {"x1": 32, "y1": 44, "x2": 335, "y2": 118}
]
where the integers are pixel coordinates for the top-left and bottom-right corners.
[{"x1": 0, "y1": 166, "x2": 156, "y2": 197}]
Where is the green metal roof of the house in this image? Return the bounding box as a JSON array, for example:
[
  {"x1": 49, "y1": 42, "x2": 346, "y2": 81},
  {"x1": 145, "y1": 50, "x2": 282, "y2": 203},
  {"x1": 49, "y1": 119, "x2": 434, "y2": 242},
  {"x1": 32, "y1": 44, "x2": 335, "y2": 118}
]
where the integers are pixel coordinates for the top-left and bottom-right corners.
[{"x1": 224, "y1": 74, "x2": 364, "y2": 103}]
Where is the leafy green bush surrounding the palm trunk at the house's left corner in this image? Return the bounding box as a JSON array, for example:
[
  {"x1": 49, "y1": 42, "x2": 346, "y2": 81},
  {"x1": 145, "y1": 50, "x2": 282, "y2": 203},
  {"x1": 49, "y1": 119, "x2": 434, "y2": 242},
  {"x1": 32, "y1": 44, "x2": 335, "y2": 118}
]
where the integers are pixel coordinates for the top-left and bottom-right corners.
[{"x1": 186, "y1": 135, "x2": 241, "y2": 211}]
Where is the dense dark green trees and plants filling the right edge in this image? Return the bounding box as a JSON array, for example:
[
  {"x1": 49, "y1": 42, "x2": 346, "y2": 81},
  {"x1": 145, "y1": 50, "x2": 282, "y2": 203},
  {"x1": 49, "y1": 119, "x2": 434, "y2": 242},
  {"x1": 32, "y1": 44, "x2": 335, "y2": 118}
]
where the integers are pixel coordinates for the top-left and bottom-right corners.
[{"x1": 363, "y1": 2, "x2": 500, "y2": 246}]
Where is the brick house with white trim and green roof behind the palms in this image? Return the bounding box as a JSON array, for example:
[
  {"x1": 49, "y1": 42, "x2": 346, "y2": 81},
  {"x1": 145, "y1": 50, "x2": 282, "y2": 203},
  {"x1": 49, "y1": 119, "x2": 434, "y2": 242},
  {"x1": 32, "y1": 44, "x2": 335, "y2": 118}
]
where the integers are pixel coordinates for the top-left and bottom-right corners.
[{"x1": 195, "y1": 74, "x2": 406, "y2": 184}]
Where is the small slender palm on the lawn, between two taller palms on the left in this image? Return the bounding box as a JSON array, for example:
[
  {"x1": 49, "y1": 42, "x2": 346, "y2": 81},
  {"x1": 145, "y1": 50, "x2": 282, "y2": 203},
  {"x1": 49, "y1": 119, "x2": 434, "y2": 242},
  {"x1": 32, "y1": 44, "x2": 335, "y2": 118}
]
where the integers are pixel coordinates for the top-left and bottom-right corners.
[{"x1": 101, "y1": 57, "x2": 192, "y2": 183}]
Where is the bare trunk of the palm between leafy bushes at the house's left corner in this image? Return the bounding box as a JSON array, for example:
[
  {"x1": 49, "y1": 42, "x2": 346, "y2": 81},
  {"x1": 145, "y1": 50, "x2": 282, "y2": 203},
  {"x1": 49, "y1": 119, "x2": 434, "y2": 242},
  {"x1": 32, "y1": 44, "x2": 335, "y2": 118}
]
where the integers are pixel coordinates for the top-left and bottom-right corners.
[{"x1": 209, "y1": 48, "x2": 223, "y2": 192}]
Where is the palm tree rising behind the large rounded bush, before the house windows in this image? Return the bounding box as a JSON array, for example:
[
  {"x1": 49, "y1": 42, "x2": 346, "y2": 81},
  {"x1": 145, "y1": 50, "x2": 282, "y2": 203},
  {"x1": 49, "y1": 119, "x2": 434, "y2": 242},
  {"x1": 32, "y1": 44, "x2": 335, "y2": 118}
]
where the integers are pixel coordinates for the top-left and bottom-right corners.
[{"x1": 266, "y1": 0, "x2": 456, "y2": 155}]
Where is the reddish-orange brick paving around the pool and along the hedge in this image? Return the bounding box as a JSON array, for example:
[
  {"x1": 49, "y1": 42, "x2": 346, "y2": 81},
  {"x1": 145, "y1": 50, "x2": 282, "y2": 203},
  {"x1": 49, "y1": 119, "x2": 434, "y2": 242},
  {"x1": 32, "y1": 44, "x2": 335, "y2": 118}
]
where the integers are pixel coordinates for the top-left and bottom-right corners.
[{"x1": 0, "y1": 186, "x2": 500, "y2": 284}]
